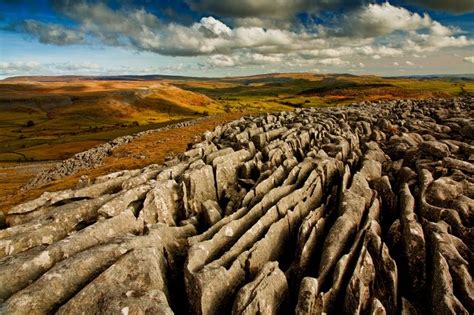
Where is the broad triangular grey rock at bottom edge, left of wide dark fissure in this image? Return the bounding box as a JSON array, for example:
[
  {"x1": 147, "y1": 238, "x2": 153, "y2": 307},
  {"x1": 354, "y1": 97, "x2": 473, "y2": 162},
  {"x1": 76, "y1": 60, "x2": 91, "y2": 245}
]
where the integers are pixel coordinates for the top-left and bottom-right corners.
[{"x1": 57, "y1": 247, "x2": 173, "y2": 314}]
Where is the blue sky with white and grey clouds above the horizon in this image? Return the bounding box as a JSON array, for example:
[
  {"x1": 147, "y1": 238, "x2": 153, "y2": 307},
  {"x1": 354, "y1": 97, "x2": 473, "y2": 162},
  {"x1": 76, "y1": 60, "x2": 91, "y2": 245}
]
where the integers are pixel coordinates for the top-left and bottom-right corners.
[{"x1": 0, "y1": 0, "x2": 474, "y2": 78}]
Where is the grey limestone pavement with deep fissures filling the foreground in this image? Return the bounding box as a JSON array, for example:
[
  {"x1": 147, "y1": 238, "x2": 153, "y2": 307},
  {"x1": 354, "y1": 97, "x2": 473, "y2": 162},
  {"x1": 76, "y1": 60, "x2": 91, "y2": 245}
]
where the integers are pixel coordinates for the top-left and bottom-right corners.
[{"x1": 0, "y1": 98, "x2": 474, "y2": 314}]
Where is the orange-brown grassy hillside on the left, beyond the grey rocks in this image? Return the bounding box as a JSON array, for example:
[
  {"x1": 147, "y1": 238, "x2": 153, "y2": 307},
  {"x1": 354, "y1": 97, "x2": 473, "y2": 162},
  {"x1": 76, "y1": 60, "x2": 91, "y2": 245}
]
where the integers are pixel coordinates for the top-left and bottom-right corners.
[{"x1": 0, "y1": 81, "x2": 223, "y2": 161}]
